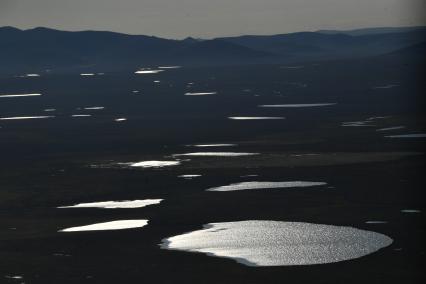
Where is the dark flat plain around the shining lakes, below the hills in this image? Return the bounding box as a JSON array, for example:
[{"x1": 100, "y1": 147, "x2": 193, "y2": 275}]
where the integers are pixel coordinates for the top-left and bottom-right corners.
[{"x1": 0, "y1": 53, "x2": 426, "y2": 283}]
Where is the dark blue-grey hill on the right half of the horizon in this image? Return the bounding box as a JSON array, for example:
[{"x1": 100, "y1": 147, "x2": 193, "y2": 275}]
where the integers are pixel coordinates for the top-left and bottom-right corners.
[{"x1": 221, "y1": 29, "x2": 426, "y2": 60}]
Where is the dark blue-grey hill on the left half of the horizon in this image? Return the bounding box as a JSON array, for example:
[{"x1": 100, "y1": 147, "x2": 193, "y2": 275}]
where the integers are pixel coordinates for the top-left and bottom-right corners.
[{"x1": 0, "y1": 28, "x2": 183, "y2": 73}]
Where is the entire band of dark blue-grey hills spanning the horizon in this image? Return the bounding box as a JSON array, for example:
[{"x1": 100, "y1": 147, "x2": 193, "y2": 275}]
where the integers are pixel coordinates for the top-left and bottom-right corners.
[{"x1": 0, "y1": 27, "x2": 426, "y2": 74}]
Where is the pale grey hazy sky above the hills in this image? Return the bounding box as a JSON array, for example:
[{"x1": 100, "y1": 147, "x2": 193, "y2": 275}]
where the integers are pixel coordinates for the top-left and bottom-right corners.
[{"x1": 0, "y1": 0, "x2": 426, "y2": 38}]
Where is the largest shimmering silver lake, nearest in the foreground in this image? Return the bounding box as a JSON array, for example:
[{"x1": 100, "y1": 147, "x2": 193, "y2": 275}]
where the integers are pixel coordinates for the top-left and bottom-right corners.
[{"x1": 160, "y1": 221, "x2": 393, "y2": 266}]
